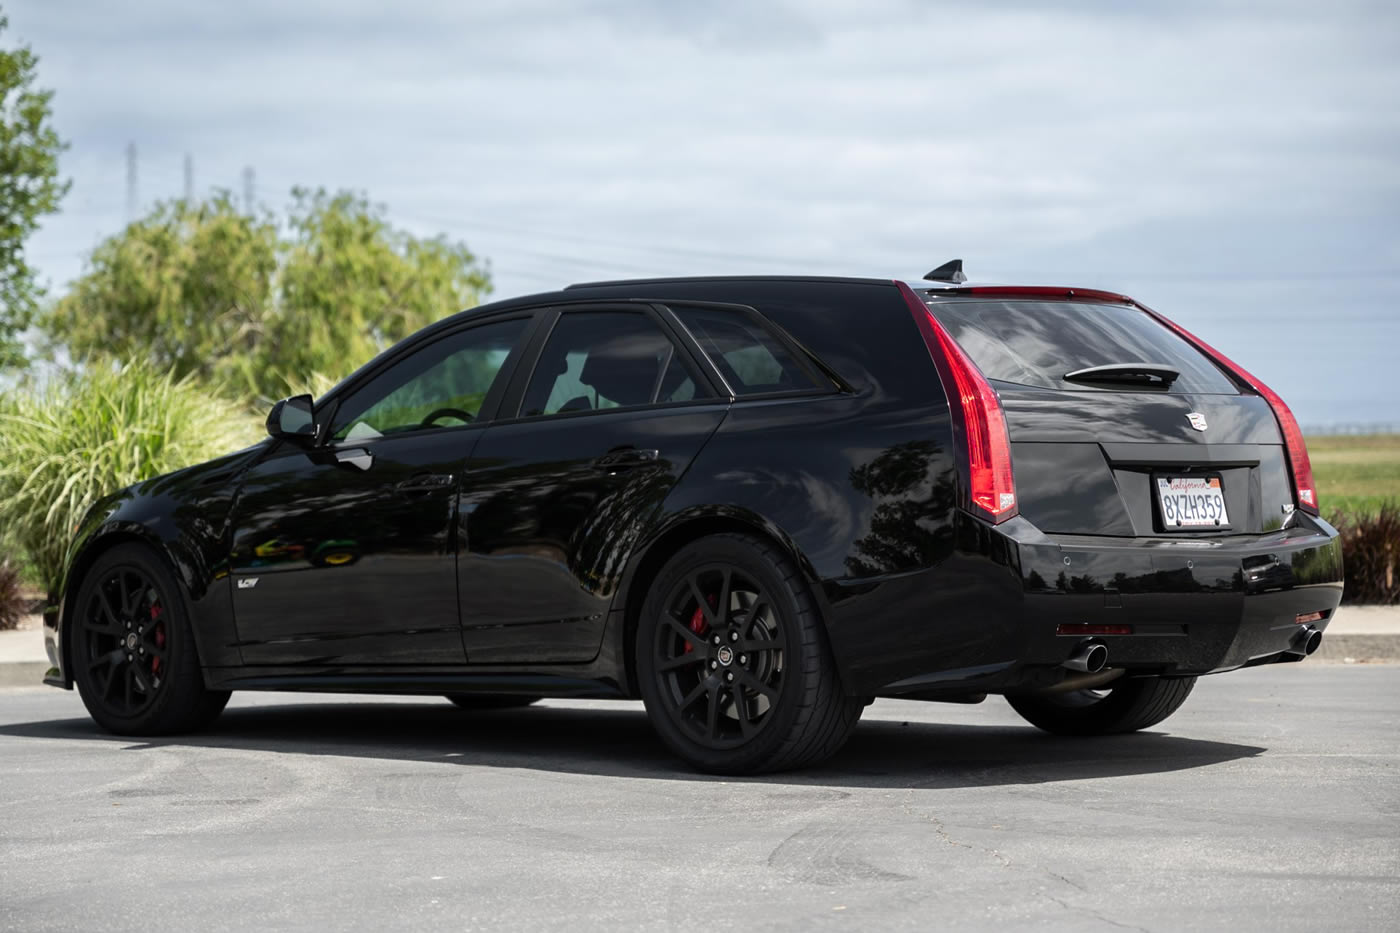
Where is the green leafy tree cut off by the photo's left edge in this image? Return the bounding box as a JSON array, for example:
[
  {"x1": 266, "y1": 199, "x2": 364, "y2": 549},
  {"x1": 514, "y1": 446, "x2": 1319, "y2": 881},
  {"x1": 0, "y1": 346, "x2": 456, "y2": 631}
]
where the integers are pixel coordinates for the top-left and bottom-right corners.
[{"x1": 0, "y1": 14, "x2": 70, "y2": 368}]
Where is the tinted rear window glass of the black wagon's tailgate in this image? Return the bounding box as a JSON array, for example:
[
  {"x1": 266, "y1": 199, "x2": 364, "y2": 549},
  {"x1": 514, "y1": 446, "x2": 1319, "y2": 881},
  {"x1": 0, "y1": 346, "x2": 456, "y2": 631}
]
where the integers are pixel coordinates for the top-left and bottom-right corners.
[{"x1": 930, "y1": 301, "x2": 1239, "y2": 395}]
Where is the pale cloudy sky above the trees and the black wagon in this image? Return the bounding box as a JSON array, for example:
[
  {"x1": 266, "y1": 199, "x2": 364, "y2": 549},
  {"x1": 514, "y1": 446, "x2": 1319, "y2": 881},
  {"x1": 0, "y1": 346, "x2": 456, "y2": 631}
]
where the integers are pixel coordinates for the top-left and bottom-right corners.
[{"x1": 3, "y1": 0, "x2": 1400, "y2": 423}]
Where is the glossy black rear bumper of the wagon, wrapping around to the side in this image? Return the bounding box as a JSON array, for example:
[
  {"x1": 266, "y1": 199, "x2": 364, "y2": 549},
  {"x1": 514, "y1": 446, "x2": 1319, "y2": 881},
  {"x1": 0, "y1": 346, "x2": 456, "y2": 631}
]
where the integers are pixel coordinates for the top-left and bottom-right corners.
[{"x1": 853, "y1": 504, "x2": 1343, "y2": 695}]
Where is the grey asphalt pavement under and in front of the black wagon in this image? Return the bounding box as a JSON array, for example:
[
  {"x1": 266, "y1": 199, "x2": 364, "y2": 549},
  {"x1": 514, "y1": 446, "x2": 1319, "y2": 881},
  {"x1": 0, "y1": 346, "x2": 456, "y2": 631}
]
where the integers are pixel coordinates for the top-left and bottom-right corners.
[{"x1": 0, "y1": 663, "x2": 1400, "y2": 932}]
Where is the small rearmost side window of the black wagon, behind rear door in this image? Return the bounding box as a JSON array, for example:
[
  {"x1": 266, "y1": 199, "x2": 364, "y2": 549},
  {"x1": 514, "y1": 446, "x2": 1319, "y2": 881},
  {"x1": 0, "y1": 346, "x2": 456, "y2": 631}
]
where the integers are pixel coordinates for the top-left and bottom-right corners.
[{"x1": 671, "y1": 305, "x2": 829, "y2": 395}]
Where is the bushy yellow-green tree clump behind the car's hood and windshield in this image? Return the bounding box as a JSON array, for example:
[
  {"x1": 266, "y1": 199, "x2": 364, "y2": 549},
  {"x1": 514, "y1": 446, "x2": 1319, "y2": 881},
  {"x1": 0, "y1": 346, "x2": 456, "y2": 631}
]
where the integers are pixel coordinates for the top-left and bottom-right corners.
[{"x1": 43, "y1": 189, "x2": 490, "y2": 403}]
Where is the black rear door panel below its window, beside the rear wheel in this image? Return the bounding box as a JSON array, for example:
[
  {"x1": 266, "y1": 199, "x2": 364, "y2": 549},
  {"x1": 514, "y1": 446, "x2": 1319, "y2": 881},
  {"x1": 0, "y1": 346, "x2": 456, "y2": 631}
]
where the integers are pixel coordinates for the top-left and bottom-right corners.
[{"x1": 458, "y1": 402, "x2": 728, "y2": 664}]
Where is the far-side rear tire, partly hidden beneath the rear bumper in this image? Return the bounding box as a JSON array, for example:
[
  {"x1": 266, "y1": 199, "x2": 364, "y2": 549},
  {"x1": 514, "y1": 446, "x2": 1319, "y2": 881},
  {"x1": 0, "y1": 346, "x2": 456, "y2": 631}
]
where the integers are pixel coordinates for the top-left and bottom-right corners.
[{"x1": 1007, "y1": 677, "x2": 1196, "y2": 735}]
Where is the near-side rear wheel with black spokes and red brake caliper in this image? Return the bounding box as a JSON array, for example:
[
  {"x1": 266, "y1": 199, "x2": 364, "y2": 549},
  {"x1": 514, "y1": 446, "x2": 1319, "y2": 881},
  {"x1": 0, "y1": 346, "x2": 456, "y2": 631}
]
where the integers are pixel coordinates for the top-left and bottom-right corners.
[{"x1": 634, "y1": 534, "x2": 865, "y2": 775}]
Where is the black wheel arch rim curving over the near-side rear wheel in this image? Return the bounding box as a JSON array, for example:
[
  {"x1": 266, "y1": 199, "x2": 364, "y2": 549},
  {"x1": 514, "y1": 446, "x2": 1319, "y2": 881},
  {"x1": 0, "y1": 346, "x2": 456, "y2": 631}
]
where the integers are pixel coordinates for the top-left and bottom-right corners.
[{"x1": 619, "y1": 507, "x2": 840, "y2": 696}]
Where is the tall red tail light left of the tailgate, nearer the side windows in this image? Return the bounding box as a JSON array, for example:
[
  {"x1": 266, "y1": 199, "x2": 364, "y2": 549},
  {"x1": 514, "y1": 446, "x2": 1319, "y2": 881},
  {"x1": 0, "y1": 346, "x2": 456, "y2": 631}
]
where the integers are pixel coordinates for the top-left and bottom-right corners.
[{"x1": 899, "y1": 282, "x2": 1016, "y2": 523}]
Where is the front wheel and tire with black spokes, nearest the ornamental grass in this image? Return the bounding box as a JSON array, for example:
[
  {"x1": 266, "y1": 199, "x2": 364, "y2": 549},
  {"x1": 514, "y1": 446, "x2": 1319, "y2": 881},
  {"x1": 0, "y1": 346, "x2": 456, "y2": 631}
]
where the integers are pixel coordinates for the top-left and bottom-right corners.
[{"x1": 66, "y1": 544, "x2": 228, "y2": 735}]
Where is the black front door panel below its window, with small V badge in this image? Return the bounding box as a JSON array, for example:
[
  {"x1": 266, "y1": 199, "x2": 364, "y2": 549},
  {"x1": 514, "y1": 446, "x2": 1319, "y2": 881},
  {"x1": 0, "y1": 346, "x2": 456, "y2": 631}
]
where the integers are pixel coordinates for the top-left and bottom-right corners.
[{"x1": 231, "y1": 429, "x2": 483, "y2": 664}]
